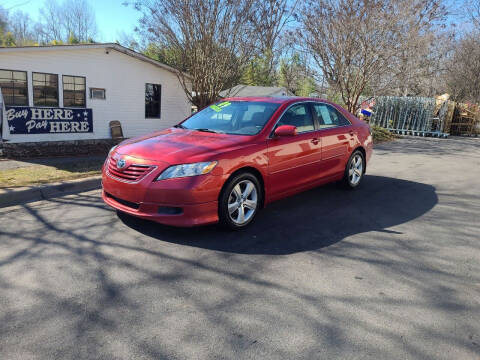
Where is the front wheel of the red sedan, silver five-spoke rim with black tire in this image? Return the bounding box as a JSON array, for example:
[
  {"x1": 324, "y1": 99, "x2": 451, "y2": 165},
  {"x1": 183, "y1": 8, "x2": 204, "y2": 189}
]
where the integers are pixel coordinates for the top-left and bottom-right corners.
[{"x1": 218, "y1": 172, "x2": 263, "y2": 230}]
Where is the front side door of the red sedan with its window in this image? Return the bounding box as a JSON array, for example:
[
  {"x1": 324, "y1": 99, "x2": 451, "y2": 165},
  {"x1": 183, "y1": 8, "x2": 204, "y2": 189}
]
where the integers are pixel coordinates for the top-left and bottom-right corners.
[{"x1": 267, "y1": 103, "x2": 321, "y2": 194}]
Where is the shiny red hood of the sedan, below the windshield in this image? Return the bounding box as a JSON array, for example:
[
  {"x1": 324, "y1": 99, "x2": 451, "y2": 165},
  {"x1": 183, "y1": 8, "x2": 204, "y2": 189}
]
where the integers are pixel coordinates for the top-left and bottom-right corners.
[{"x1": 115, "y1": 128, "x2": 250, "y2": 164}]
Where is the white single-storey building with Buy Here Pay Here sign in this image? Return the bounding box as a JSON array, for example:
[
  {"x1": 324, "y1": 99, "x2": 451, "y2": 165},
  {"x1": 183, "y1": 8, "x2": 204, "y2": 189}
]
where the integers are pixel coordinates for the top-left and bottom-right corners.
[{"x1": 0, "y1": 44, "x2": 191, "y2": 143}]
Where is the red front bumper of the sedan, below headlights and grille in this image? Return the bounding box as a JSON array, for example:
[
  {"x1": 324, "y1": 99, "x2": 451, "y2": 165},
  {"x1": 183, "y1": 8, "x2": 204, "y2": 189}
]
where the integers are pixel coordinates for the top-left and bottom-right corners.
[{"x1": 102, "y1": 156, "x2": 223, "y2": 227}]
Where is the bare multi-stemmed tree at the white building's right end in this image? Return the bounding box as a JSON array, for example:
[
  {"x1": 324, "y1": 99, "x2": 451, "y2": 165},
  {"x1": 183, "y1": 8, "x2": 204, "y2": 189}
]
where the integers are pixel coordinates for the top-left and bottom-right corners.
[{"x1": 131, "y1": 0, "x2": 258, "y2": 108}]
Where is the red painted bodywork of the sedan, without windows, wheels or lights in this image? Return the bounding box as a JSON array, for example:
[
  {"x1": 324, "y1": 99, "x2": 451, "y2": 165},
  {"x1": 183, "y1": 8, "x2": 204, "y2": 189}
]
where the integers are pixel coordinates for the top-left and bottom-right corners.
[{"x1": 102, "y1": 97, "x2": 372, "y2": 226}]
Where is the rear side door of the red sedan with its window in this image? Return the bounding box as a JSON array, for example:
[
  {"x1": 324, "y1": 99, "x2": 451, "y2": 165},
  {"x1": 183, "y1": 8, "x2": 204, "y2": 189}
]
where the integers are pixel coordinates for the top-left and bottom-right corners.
[{"x1": 313, "y1": 103, "x2": 354, "y2": 178}]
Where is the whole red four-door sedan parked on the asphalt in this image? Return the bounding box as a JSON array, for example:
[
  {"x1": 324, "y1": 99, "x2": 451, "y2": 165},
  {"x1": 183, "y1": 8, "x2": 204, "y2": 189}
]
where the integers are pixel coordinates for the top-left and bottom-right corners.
[{"x1": 102, "y1": 97, "x2": 372, "y2": 229}]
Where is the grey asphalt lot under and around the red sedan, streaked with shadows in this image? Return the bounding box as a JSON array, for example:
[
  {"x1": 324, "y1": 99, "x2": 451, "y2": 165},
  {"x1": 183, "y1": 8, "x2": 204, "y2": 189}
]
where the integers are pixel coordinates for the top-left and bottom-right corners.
[{"x1": 0, "y1": 138, "x2": 480, "y2": 359}]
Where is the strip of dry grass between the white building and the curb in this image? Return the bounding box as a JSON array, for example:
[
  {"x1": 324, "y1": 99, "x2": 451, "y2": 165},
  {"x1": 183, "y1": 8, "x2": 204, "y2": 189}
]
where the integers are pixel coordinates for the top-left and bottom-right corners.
[{"x1": 0, "y1": 159, "x2": 103, "y2": 188}]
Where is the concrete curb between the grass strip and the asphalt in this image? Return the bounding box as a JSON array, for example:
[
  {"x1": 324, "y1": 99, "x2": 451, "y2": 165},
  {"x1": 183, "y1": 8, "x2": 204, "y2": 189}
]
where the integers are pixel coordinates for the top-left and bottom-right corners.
[{"x1": 0, "y1": 175, "x2": 102, "y2": 208}]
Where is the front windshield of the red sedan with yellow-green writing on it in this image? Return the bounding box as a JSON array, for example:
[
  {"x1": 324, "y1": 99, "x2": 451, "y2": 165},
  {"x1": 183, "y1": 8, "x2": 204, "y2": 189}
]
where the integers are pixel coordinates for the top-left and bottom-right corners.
[{"x1": 177, "y1": 101, "x2": 280, "y2": 135}]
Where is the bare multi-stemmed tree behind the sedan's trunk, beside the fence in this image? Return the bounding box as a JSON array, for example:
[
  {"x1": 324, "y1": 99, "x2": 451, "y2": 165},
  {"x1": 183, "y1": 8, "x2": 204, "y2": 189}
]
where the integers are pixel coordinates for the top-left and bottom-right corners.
[{"x1": 298, "y1": 0, "x2": 445, "y2": 112}]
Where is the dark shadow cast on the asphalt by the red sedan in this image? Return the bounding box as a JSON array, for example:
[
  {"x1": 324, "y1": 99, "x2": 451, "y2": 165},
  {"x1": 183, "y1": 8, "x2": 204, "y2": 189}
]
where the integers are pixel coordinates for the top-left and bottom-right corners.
[{"x1": 118, "y1": 175, "x2": 438, "y2": 255}]
